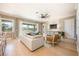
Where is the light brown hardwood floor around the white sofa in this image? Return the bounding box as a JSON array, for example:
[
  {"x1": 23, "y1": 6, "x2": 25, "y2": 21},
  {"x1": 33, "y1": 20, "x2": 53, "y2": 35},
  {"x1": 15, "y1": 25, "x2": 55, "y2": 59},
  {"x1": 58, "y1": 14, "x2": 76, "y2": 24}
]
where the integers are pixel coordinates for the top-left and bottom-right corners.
[{"x1": 5, "y1": 39, "x2": 77, "y2": 56}]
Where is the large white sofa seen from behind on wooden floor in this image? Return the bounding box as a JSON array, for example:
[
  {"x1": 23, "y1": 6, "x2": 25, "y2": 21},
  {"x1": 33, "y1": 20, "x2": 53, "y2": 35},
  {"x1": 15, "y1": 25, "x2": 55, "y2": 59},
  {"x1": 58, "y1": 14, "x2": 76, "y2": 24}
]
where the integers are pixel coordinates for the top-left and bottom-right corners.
[{"x1": 20, "y1": 35, "x2": 44, "y2": 51}]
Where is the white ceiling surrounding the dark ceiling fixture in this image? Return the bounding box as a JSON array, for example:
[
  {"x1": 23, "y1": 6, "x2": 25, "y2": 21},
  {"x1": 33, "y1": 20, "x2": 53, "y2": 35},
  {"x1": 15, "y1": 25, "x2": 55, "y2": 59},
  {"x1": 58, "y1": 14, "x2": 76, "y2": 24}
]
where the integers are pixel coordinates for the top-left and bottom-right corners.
[{"x1": 0, "y1": 3, "x2": 75, "y2": 21}]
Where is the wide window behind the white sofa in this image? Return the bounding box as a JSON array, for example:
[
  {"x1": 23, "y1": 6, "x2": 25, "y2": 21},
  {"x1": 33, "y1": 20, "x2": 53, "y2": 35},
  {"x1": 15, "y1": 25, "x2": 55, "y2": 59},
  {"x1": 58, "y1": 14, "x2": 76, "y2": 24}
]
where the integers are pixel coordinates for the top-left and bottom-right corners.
[{"x1": 22, "y1": 23, "x2": 37, "y2": 32}]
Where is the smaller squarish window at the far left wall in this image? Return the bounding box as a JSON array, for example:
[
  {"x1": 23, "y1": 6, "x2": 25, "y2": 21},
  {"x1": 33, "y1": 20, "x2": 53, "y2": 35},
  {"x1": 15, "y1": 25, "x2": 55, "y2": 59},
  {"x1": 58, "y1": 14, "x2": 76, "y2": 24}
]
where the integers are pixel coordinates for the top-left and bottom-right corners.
[{"x1": 2, "y1": 20, "x2": 12, "y2": 32}]
